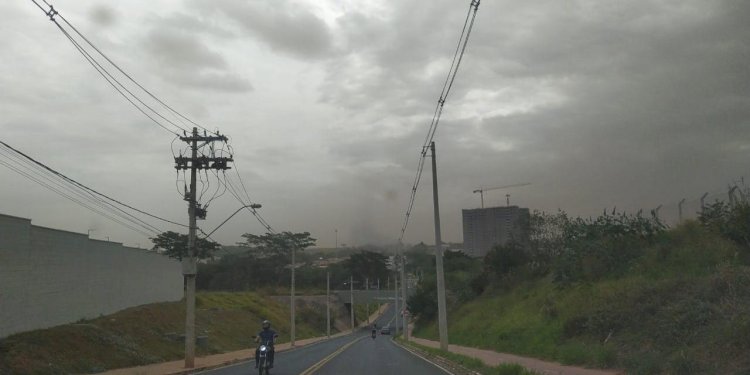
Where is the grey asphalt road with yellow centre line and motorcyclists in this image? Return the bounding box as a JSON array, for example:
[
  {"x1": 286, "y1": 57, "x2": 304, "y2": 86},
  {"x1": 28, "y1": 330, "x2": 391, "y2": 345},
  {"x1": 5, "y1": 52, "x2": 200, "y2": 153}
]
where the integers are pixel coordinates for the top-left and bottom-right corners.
[{"x1": 201, "y1": 307, "x2": 446, "y2": 375}]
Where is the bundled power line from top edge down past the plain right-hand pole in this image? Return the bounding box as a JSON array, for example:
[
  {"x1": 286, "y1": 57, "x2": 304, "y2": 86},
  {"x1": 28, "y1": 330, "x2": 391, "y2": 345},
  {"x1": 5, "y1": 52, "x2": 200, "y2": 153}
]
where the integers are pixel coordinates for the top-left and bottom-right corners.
[{"x1": 398, "y1": 0, "x2": 480, "y2": 243}]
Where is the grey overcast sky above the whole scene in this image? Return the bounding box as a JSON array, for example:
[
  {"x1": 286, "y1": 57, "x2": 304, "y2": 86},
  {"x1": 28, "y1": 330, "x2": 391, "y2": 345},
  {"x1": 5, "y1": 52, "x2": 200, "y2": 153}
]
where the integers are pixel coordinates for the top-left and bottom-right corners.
[{"x1": 0, "y1": 0, "x2": 750, "y2": 247}]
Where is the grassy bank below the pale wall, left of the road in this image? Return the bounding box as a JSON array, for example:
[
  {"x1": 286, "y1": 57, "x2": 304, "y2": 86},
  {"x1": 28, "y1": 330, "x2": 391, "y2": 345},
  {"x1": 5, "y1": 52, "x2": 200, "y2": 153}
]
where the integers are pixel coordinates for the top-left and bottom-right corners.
[{"x1": 0, "y1": 292, "x2": 334, "y2": 374}]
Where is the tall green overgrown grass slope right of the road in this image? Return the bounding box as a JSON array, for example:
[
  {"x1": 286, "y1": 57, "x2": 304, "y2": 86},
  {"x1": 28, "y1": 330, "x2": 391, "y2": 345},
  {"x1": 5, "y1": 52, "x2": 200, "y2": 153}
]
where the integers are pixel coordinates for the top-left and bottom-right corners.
[{"x1": 416, "y1": 223, "x2": 750, "y2": 374}]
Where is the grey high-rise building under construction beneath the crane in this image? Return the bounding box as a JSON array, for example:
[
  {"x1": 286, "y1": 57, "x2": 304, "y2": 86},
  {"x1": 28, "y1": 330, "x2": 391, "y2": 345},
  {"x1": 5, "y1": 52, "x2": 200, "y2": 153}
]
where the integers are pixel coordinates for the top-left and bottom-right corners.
[{"x1": 461, "y1": 206, "x2": 529, "y2": 257}]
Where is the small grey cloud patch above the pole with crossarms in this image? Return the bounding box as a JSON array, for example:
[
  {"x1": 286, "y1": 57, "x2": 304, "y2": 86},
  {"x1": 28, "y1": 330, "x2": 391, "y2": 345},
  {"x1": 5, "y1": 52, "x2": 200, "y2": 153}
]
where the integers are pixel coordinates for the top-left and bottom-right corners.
[{"x1": 146, "y1": 27, "x2": 252, "y2": 92}]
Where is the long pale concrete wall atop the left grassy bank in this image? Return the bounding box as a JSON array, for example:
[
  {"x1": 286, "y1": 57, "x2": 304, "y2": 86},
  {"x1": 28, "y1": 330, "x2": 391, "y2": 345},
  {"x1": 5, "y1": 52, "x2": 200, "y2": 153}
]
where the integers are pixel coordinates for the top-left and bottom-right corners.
[{"x1": 0, "y1": 214, "x2": 183, "y2": 337}]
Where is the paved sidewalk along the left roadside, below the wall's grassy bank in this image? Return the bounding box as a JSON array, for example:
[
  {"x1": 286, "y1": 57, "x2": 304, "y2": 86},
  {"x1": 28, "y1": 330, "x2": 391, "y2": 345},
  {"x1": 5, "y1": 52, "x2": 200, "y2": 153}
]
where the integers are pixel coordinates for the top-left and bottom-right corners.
[{"x1": 103, "y1": 304, "x2": 388, "y2": 375}]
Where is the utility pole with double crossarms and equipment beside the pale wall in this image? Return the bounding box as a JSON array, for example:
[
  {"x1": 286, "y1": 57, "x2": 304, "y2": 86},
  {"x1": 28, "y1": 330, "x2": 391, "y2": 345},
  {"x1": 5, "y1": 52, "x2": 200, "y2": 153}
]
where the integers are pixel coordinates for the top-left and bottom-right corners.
[{"x1": 174, "y1": 127, "x2": 233, "y2": 368}]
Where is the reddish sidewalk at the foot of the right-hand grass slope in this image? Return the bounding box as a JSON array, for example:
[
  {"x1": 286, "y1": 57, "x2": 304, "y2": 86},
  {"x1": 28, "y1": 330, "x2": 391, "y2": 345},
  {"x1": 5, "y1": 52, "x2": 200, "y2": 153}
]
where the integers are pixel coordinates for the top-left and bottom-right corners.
[{"x1": 409, "y1": 326, "x2": 624, "y2": 375}]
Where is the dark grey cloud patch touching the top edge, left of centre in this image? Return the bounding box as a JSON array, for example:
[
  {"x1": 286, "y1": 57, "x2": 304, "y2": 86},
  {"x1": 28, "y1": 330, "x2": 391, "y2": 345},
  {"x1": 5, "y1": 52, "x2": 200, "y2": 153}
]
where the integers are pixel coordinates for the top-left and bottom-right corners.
[{"x1": 191, "y1": 0, "x2": 332, "y2": 59}]
